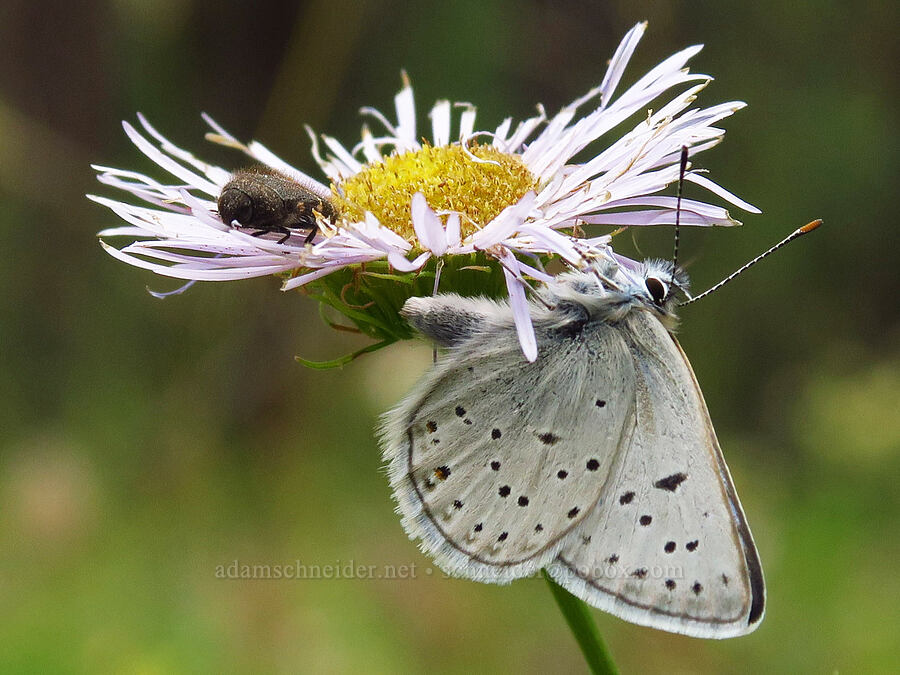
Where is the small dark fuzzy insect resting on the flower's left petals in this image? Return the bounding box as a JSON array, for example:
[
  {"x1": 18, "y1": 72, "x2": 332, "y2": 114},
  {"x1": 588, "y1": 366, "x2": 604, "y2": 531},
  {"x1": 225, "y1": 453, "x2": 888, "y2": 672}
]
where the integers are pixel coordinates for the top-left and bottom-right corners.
[{"x1": 218, "y1": 166, "x2": 335, "y2": 244}]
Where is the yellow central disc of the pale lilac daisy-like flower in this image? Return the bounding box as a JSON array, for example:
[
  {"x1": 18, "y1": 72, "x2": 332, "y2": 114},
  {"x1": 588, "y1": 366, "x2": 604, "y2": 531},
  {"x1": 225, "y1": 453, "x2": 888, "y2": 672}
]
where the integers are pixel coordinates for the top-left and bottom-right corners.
[{"x1": 332, "y1": 143, "x2": 537, "y2": 246}]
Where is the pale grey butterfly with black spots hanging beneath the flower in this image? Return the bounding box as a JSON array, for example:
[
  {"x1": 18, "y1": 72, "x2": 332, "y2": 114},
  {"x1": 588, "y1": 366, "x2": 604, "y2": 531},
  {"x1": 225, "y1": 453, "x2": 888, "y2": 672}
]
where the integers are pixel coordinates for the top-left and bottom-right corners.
[{"x1": 380, "y1": 260, "x2": 765, "y2": 638}]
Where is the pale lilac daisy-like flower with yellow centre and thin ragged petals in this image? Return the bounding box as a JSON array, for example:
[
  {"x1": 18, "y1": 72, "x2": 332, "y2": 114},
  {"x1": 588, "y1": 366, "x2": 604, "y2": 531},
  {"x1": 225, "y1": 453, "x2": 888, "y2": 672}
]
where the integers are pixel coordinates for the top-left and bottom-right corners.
[{"x1": 91, "y1": 23, "x2": 758, "y2": 360}]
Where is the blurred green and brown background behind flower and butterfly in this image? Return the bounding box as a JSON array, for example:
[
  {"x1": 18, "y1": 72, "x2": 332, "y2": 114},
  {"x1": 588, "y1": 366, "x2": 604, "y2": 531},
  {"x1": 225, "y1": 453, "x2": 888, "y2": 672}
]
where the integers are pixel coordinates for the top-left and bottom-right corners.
[{"x1": 0, "y1": 0, "x2": 900, "y2": 673}]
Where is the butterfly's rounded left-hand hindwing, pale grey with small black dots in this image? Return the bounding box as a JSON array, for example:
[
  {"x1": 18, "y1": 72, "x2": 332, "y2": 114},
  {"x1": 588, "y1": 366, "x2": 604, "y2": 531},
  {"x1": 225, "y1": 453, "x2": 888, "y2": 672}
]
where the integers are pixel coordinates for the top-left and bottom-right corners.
[{"x1": 382, "y1": 296, "x2": 634, "y2": 583}]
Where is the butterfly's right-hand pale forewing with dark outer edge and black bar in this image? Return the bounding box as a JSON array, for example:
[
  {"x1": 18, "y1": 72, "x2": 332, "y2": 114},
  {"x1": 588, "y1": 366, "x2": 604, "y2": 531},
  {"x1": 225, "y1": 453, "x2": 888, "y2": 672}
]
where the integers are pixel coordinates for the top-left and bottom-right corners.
[{"x1": 550, "y1": 312, "x2": 765, "y2": 638}]
